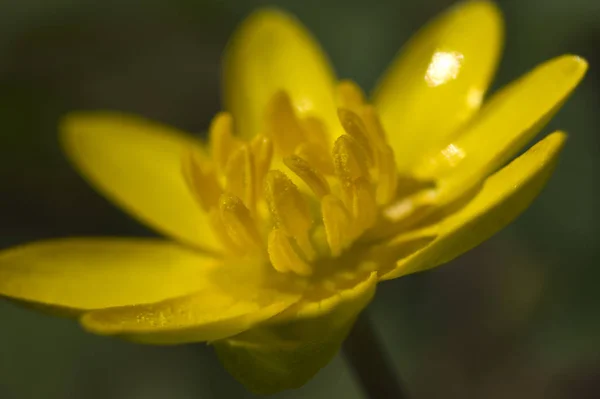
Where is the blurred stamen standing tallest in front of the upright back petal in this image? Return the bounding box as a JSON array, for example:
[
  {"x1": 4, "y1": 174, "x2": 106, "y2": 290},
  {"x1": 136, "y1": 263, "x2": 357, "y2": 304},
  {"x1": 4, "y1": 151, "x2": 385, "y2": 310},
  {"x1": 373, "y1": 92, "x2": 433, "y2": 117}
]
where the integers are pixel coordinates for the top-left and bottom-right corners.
[{"x1": 266, "y1": 91, "x2": 307, "y2": 156}]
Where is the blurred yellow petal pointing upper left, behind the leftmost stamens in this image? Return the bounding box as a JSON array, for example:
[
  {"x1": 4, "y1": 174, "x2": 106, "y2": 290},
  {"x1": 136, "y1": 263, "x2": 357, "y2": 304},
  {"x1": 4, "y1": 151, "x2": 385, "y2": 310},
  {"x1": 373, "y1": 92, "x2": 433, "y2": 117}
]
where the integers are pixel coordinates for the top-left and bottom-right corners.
[{"x1": 61, "y1": 112, "x2": 219, "y2": 250}]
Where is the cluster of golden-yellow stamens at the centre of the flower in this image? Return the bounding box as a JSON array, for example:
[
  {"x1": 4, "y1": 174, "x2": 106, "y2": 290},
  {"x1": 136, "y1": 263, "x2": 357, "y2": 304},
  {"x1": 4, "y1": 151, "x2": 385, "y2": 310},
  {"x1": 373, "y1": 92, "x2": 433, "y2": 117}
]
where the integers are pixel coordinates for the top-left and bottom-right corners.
[{"x1": 183, "y1": 82, "x2": 432, "y2": 276}]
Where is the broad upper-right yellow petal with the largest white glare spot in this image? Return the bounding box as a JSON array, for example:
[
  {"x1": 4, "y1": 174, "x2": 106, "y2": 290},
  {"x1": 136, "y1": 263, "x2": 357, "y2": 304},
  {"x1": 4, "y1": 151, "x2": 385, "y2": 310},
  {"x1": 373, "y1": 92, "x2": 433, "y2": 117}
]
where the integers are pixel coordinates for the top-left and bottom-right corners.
[{"x1": 373, "y1": 1, "x2": 503, "y2": 171}]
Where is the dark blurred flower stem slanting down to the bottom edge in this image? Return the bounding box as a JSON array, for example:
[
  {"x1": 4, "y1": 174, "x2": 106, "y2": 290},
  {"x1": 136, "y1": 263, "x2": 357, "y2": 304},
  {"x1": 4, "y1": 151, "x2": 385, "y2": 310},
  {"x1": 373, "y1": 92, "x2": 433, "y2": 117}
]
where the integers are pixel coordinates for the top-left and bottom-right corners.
[{"x1": 343, "y1": 312, "x2": 408, "y2": 399}]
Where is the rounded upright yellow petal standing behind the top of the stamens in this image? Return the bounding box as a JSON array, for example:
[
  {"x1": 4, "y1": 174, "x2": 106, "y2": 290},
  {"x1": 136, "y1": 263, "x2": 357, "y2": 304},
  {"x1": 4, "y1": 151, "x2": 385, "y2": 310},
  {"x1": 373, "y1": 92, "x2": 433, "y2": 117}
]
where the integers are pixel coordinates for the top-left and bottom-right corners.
[{"x1": 223, "y1": 9, "x2": 339, "y2": 142}]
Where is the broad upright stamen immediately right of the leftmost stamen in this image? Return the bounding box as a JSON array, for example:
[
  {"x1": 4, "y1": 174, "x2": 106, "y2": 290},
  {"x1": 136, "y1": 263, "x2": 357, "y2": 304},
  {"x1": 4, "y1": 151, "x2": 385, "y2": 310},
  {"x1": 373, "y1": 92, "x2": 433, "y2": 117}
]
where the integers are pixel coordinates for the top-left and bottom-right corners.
[{"x1": 225, "y1": 144, "x2": 256, "y2": 213}]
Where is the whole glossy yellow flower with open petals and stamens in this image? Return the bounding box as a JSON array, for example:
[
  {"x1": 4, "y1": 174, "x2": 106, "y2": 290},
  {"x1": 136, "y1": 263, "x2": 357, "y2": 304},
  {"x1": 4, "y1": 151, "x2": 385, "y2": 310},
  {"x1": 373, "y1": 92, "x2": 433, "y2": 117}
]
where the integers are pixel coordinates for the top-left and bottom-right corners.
[{"x1": 0, "y1": 1, "x2": 587, "y2": 393}]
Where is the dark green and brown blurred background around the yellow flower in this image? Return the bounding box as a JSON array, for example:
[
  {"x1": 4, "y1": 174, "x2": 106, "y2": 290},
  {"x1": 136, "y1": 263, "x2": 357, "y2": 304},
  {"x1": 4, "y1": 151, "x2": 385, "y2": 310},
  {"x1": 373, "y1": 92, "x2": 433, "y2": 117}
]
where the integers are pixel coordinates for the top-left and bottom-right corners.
[{"x1": 0, "y1": 0, "x2": 600, "y2": 399}]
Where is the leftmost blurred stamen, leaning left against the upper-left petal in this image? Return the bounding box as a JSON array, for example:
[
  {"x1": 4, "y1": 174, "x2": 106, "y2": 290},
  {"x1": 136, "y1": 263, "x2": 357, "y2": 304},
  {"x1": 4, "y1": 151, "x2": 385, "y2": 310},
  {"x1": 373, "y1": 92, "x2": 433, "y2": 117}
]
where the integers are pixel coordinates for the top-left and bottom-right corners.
[{"x1": 181, "y1": 151, "x2": 222, "y2": 212}]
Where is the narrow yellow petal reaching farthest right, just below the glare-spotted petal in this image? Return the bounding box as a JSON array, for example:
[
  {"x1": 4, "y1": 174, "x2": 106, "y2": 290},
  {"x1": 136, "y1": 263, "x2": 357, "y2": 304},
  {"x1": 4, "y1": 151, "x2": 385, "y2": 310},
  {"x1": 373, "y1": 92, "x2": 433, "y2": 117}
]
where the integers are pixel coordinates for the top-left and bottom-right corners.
[{"x1": 413, "y1": 55, "x2": 587, "y2": 193}]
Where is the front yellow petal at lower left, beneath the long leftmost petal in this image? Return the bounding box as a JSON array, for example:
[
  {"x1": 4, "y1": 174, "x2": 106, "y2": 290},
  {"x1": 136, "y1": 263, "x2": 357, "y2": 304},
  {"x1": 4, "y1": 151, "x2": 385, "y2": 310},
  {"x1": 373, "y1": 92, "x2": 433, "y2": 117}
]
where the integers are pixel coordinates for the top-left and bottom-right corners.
[{"x1": 81, "y1": 264, "x2": 303, "y2": 345}]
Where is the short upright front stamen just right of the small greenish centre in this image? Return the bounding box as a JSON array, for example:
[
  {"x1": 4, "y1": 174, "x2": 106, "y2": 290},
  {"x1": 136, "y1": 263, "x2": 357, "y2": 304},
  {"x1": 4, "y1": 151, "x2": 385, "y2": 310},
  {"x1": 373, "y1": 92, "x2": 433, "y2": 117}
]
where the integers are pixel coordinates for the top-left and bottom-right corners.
[{"x1": 321, "y1": 194, "x2": 352, "y2": 256}]
